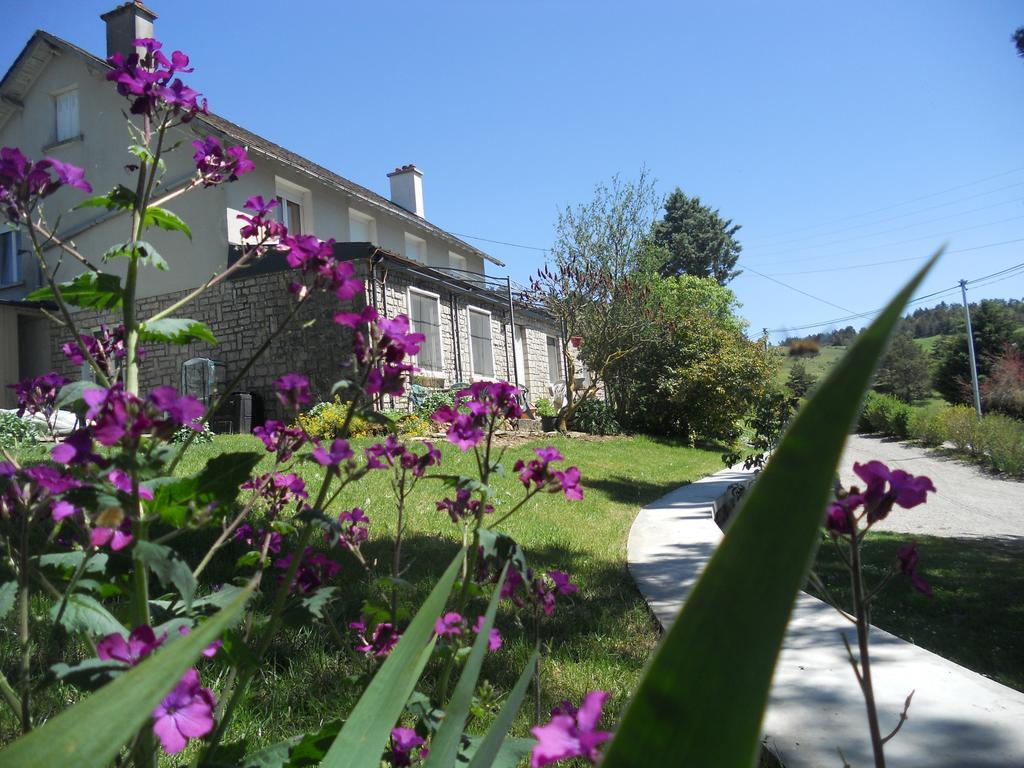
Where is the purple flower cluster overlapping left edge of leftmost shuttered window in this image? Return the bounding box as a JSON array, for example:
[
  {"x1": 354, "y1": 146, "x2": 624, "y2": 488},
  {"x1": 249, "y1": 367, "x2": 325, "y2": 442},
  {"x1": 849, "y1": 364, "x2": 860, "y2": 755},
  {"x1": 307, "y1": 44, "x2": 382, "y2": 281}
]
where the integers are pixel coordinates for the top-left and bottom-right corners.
[{"x1": 334, "y1": 306, "x2": 426, "y2": 395}]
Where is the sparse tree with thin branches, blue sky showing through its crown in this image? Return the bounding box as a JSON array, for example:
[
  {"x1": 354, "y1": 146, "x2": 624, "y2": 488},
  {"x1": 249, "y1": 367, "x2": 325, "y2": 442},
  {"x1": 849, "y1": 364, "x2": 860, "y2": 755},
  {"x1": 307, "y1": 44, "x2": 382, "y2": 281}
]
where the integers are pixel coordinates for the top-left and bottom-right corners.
[{"x1": 532, "y1": 171, "x2": 662, "y2": 432}]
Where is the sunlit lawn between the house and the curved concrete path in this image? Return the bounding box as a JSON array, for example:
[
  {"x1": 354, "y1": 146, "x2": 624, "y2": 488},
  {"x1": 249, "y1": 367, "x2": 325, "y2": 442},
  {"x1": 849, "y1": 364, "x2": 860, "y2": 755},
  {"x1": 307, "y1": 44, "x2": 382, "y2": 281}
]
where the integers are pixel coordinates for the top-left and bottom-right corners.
[{"x1": 0, "y1": 436, "x2": 721, "y2": 756}]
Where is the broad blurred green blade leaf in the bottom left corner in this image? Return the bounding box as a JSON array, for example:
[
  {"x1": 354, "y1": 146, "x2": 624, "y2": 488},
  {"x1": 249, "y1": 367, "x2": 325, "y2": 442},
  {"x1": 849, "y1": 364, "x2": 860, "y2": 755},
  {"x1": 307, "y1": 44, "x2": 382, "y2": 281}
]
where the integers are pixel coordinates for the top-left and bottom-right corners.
[{"x1": 0, "y1": 585, "x2": 252, "y2": 768}]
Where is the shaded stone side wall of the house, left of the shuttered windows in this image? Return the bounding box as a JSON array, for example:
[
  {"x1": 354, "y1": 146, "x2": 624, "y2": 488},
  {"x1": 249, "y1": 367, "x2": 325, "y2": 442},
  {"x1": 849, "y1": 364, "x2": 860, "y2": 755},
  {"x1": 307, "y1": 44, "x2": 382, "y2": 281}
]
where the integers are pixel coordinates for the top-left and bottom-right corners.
[{"x1": 50, "y1": 272, "x2": 361, "y2": 418}]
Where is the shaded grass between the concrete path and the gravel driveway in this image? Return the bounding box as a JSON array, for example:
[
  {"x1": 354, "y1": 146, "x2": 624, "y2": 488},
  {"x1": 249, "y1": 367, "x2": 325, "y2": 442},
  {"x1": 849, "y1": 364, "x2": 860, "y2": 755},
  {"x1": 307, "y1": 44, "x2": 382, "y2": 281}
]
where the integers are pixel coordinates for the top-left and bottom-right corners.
[{"x1": 816, "y1": 531, "x2": 1024, "y2": 691}]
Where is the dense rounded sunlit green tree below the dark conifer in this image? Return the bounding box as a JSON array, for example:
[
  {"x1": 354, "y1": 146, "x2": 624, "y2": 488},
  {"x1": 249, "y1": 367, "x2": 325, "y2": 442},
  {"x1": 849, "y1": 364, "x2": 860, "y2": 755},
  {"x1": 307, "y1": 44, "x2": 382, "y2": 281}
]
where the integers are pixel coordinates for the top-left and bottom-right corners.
[{"x1": 608, "y1": 275, "x2": 775, "y2": 442}]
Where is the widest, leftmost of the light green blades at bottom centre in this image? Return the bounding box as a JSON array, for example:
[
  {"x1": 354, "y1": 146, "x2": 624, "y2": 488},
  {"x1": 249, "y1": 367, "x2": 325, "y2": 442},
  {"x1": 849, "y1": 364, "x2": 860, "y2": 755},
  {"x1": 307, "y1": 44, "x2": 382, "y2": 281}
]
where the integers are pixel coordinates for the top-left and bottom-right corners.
[{"x1": 322, "y1": 547, "x2": 466, "y2": 768}]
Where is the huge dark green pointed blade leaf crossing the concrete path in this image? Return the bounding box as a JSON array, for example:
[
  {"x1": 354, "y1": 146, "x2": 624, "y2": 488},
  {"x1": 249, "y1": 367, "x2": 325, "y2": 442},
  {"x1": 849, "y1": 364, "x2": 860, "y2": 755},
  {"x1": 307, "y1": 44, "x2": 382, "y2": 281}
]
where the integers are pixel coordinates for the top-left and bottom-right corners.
[{"x1": 602, "y1": 252, "x2": 941, "y2": 768}]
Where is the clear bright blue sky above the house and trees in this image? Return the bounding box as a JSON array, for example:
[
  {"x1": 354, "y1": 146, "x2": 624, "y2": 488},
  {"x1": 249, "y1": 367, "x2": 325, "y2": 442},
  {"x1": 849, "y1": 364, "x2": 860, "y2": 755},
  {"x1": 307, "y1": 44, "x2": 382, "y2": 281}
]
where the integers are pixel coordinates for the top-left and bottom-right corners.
[{"x1": 0, "y1": 0, "x2": 1024, "y2": 339}]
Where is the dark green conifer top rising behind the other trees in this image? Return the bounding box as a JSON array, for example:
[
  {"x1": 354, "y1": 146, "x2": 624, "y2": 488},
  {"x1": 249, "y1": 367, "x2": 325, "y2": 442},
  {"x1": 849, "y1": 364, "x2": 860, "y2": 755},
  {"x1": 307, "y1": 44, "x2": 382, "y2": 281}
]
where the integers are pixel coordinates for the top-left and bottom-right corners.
[{"x1": 654, "y1": 186, "x2": 742, "y2": 286}]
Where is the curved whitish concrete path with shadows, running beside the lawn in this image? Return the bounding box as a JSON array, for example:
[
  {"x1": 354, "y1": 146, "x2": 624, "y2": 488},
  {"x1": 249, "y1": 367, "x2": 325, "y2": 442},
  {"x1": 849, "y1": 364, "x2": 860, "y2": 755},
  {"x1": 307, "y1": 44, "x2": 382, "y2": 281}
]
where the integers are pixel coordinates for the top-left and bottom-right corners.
[{"x1": 627, "y1": 462, "x2": 1024, "y2": 768}]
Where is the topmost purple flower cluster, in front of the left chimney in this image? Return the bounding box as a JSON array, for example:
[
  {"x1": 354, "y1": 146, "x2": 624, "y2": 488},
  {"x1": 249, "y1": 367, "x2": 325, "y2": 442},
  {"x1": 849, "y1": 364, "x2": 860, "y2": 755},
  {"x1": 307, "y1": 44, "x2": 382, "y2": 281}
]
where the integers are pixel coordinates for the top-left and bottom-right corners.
[{"x1": 106, "y1": 38, "x2": 207, "y2": 123}]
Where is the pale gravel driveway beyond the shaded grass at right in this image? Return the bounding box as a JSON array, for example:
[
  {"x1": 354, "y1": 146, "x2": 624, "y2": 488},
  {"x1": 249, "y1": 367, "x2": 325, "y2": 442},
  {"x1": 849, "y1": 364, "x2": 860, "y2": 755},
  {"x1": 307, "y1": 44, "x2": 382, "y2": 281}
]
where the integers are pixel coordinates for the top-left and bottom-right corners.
[{"x1": 839, "y1": 435, "x2": 1024, "y2": 548}]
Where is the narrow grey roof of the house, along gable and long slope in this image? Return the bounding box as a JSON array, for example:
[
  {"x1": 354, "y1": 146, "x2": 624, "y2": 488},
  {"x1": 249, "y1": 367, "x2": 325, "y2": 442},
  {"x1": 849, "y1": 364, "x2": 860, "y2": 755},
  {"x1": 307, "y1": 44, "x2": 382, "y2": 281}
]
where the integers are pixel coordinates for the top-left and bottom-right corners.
[{"x1": 0, "y1": 30, "x2": 505, "y2": 266}]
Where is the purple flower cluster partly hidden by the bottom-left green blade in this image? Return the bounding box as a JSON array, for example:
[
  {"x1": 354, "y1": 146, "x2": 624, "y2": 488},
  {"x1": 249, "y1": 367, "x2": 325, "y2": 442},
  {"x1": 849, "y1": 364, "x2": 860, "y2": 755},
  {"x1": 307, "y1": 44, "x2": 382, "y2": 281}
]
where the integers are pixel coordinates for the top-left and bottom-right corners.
[{"x1": 96, "y1": 625, "x2": 220, "y2": 755}]
